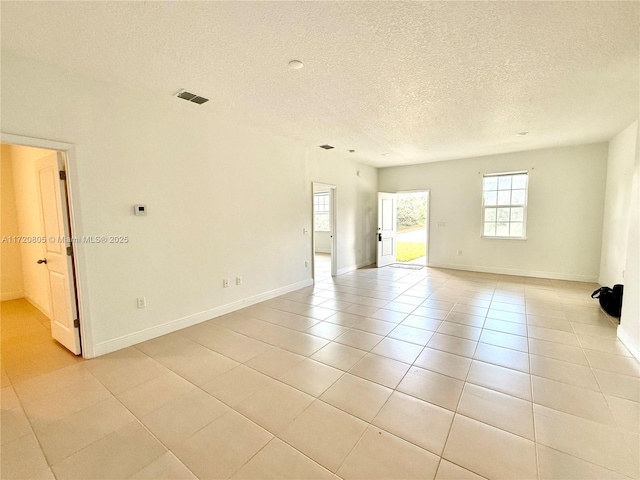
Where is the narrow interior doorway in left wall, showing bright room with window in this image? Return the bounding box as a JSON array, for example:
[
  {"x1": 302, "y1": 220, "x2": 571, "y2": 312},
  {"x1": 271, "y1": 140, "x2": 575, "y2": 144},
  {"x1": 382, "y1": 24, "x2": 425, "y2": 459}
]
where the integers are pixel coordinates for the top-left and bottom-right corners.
[{"x1": 312, "y1": 182, "x2": 337, "y2": 282}]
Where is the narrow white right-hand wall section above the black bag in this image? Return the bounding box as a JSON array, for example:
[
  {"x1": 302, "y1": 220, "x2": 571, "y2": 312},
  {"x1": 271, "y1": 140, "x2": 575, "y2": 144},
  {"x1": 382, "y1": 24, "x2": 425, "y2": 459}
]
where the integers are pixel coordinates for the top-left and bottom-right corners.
[{"x1": 598, "y1": 122, "x2": 638, "y2": 286}]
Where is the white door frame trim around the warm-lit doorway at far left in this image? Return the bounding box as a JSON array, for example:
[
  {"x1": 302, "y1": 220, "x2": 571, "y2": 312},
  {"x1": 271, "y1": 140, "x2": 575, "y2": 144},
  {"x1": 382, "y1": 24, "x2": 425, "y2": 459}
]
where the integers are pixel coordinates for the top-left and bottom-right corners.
[{"x1": 0, "y1": 132, "x2": 95, "y2": 358}]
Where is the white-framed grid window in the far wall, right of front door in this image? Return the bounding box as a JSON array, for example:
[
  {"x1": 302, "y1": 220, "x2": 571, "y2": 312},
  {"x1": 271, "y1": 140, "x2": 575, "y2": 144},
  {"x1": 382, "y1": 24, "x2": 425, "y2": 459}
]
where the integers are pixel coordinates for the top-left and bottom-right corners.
[{"x1": 482, "y1": 172, "x2": 528, "y2": 239}]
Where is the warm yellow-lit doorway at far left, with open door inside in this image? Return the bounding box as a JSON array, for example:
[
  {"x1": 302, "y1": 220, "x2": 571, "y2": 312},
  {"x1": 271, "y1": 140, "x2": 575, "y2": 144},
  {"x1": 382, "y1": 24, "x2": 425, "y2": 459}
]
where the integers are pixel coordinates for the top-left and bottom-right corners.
[{"x1": 0, "y1": 141, "x2": 82, "y2": 374}]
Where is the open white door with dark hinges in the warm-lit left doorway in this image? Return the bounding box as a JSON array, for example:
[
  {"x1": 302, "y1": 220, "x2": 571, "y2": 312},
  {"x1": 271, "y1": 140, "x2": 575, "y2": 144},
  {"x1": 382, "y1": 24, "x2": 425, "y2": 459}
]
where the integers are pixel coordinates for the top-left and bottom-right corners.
[{"x1": 36, "y1": 152, "x2": 81, "y2": 355}]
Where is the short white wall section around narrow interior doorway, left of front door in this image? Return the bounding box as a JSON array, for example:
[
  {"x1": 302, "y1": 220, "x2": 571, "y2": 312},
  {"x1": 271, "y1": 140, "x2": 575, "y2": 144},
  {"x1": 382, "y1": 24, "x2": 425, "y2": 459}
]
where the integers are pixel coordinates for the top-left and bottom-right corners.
[{"x1": 308, "y1": 148, "x2": 378, "y2": 275}]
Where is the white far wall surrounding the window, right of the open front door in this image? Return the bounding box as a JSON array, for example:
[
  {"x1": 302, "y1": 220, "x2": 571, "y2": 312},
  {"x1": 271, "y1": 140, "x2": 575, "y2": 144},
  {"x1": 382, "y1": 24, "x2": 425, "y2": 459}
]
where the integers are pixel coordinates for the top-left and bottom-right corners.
[{"x1": 379, "y1": 143, "x2": 607, "y2": 281}]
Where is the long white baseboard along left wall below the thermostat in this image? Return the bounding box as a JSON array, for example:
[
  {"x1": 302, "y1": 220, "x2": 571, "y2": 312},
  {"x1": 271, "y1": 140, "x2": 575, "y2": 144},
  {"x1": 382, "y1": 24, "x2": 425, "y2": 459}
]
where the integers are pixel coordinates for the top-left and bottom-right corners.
[{"x1": 93, "y1": 279, "x2": 313, "y2": 357}]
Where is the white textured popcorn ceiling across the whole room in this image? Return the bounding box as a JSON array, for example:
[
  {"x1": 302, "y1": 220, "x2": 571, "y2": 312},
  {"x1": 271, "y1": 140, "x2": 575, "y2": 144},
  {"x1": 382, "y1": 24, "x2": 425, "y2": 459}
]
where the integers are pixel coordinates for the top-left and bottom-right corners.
[{"x1": 1, "y1": 0, "x2": 640, "y2": 167}]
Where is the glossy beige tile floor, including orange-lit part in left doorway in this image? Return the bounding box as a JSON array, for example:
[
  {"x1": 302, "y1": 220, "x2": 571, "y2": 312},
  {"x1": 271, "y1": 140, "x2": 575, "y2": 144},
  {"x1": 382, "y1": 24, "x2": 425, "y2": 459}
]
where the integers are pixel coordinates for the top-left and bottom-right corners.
[{"x1": 1, "y1": 268, "x2": 640, "y2": 480}]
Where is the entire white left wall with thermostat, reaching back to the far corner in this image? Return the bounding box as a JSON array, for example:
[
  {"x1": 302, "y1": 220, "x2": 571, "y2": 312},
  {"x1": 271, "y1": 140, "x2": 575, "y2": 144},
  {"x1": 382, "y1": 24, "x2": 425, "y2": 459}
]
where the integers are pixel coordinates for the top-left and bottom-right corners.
[{"x1": 1, "y1": 53, "x2": 376, "y2": 356}]
